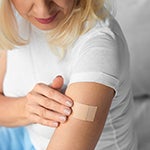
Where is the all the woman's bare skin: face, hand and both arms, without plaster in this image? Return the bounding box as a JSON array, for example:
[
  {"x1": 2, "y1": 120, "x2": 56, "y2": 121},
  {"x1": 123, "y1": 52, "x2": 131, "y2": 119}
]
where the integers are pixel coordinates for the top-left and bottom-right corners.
[{"x1": 0, "y1": 0, "x2": 115, "y2": 150}]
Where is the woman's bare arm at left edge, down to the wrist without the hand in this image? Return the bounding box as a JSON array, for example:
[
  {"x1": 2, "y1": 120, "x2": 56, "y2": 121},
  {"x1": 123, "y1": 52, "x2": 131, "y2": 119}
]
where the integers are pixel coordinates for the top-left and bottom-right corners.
[{"x1": 0, "y1": 51, "x2": 29, "y2": 126}]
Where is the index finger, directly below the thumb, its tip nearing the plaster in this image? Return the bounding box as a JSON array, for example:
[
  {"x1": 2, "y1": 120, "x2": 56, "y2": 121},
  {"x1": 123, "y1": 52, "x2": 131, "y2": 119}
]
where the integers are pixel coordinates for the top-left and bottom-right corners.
[{"x1": 34, "y1": 83, "x2": 73, "y2": 107}]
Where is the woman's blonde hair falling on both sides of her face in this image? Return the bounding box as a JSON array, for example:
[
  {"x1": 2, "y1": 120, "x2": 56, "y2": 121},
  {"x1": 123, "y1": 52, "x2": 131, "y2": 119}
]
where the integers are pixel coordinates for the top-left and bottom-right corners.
[{"x1": 0, "y1": 0, "x2": 106, "y2": 51}]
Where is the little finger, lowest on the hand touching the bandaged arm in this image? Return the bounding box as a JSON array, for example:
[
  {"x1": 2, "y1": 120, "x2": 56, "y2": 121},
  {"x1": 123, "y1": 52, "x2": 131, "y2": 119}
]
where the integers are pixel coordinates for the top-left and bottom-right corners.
[{"x1": 30, "y1": 114, "x2": 59, "y2": 128}]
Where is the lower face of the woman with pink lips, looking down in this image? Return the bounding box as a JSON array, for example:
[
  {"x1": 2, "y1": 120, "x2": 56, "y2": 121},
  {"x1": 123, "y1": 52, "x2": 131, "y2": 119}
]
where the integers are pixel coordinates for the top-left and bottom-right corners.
[{"x1": 11, "y1": 0, "x2": 75, "y2": 30}]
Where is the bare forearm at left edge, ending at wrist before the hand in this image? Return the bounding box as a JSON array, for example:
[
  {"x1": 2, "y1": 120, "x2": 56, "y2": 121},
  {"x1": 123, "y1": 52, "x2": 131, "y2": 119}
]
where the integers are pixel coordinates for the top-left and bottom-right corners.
[{"x1": 0, "y1": 94, "x2": 29, "y2": 127}]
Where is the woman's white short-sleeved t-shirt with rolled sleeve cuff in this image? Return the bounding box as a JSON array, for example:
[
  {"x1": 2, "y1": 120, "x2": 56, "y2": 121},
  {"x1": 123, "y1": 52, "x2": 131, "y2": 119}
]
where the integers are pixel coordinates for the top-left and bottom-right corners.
[{"x1": 3, "y1": 14, "x2": 136, "y2": 150}]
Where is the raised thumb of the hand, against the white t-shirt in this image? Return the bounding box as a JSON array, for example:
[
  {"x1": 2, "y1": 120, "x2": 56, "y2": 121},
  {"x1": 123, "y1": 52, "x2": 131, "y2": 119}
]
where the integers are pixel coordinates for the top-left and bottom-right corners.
[{"x1": 51, "y1": 76, "x2": 64, "y2": 90}]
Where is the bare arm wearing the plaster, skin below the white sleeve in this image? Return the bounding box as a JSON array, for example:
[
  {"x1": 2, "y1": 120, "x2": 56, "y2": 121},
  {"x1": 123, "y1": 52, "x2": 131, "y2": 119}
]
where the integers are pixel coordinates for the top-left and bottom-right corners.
[{"x1": 47, "y1": 83, "x2": 114, "y2": 150}]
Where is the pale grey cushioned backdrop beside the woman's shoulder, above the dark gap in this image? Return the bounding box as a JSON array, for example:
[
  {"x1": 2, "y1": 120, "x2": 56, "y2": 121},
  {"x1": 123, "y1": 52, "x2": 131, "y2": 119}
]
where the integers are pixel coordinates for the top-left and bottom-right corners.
[{"x1": 117, "y1": 0, "x2": 150, "y2": 95}]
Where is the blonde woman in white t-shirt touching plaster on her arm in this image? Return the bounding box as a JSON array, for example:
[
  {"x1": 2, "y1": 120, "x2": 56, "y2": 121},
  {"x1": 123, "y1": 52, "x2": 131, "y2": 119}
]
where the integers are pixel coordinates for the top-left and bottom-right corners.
[{"x1": 0, "y1": 0, "x2": 136, "y2": 150}]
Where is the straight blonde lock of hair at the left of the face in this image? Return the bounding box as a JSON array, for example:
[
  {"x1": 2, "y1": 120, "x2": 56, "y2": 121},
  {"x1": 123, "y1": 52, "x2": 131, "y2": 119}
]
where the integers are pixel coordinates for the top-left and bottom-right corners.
[{"x1": 0, "y1": 0, "x2": 26, "y2": 50}]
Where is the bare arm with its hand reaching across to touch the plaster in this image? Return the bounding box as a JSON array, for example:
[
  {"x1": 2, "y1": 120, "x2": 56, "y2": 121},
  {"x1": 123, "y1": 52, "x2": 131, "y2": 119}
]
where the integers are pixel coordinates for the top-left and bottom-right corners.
[{"x1": 0, "y1": 52, "x2": 71, "y2": 127}]
